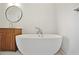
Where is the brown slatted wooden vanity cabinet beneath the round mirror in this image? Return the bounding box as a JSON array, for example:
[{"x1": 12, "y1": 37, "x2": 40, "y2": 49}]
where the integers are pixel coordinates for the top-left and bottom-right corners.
[{"x1": 0, "y1": 28, "x2": 22, "y2": 51}]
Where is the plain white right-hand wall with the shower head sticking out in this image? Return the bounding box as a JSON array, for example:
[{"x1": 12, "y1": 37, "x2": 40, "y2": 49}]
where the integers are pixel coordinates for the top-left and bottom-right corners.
[{"x1": 56, "y1": 4, "x2": 79, "y2": 54}]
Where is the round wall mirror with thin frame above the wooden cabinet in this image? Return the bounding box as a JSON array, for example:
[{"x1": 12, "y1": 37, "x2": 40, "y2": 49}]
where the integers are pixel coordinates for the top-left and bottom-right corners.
[{"x1": 5, "y1": 6, "x2": 23, "y2": 23}]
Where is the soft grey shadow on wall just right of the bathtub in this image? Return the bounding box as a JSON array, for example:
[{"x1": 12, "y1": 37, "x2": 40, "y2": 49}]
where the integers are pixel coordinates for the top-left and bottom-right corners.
[{"x1": 61, "y1": 36, "x2": 70, "y2": 54}]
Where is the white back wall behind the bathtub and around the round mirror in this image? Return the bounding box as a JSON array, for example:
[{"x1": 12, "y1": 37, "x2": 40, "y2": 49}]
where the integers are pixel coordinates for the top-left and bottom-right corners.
[{"x1": 0, "y1": 3, "x2": 57, "y2": 33}]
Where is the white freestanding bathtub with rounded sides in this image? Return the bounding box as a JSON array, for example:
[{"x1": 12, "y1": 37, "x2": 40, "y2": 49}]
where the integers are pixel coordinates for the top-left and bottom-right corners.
[{"x1": 16, "y1": 34, "x2": 62, "y2": 55}]
